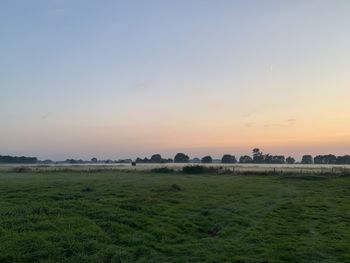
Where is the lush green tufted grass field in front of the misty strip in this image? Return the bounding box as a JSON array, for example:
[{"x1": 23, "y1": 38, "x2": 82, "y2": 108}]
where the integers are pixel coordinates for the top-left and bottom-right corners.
[{"x1": 0, "y1": 171, "x2": 350, "y2": 263}]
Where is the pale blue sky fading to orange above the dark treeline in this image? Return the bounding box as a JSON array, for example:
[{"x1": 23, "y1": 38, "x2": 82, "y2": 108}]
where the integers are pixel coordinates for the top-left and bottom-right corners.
[{"x1": 0, "y1": 0, "x2": 350, "y2": 160}]
